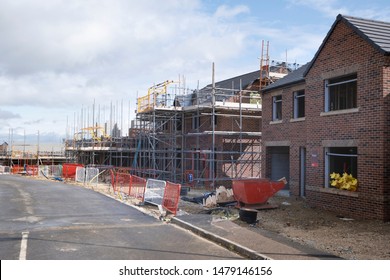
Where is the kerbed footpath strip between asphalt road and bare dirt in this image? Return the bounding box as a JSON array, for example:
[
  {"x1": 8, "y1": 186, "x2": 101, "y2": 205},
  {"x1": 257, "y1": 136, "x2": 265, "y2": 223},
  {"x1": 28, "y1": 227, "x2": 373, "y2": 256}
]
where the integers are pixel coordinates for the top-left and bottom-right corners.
[{"x1": 171, "y1": 214, "x2": 340, "y2": 260}]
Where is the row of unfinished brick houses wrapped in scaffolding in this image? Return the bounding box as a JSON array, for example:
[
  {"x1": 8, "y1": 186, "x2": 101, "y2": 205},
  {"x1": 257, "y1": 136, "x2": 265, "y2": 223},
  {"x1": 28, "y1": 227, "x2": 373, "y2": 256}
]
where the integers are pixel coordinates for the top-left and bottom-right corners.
[{"x1": 66, "y1": 59, "x2": 287, "y2": 187}]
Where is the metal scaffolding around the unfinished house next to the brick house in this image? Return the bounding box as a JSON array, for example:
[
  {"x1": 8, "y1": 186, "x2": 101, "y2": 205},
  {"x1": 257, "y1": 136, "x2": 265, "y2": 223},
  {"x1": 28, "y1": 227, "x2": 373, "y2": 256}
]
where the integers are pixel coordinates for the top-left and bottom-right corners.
[{"x1": 132, "y1": 68, "x2": 261, "y2": 187}]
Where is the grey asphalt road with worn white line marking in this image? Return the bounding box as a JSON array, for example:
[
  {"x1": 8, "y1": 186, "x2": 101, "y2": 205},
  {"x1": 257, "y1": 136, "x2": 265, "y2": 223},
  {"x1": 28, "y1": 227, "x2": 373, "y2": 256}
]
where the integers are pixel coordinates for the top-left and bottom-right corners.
[{"x1": 0, "y1": 175, "x2": 240, "y2": 260}]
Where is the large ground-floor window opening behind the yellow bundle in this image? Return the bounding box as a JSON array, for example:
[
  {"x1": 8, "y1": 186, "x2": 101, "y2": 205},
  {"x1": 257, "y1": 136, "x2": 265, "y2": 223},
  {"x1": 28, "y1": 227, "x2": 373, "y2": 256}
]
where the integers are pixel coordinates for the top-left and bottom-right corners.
[{"x1": 325, "y1": 147, "x2": 358, "y2": 187}]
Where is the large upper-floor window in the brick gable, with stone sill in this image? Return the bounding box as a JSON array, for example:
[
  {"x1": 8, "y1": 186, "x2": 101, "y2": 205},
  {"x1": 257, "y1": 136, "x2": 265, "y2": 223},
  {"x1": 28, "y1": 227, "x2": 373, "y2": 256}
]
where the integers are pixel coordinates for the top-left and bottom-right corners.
[{"x1": 325, "y1": 74, "x2": 357, "y2": 112}]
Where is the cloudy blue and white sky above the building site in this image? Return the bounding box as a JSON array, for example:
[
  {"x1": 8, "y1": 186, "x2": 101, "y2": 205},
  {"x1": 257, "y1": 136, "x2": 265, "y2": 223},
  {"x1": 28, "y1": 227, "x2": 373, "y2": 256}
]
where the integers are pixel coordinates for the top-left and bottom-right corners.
[{"x1": 0, "y1": 0, "x2": 390, "y2": 149}]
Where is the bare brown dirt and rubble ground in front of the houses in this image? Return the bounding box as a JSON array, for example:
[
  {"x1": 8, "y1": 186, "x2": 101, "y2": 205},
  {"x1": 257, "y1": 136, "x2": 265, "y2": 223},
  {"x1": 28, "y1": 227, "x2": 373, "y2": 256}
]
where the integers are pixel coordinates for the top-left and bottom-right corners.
[{"x1": 83, "y1": 186, "x2": 390, "y2": 260}]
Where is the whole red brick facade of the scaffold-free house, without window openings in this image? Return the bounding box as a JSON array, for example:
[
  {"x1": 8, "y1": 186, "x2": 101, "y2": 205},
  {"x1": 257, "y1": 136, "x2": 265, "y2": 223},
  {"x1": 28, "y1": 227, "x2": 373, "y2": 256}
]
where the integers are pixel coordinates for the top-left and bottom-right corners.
[{"x1": 263, "y1": 21, "x2": 390, "y2": 220}]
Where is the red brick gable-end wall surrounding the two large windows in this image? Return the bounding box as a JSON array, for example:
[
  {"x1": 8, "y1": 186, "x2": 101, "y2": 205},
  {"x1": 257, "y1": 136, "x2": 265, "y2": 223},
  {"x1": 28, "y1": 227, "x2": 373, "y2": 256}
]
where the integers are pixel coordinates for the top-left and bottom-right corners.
[{"x1": 306, "y1": 22, "x2": 385, "y2": 219}]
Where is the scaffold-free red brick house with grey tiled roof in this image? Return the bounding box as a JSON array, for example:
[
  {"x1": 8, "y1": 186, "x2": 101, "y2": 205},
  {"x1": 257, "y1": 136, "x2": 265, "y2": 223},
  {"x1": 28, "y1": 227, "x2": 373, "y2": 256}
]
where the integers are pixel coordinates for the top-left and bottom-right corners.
[{"x1": 262, "y1": 15, "x2": 390, "y2": 221}]
